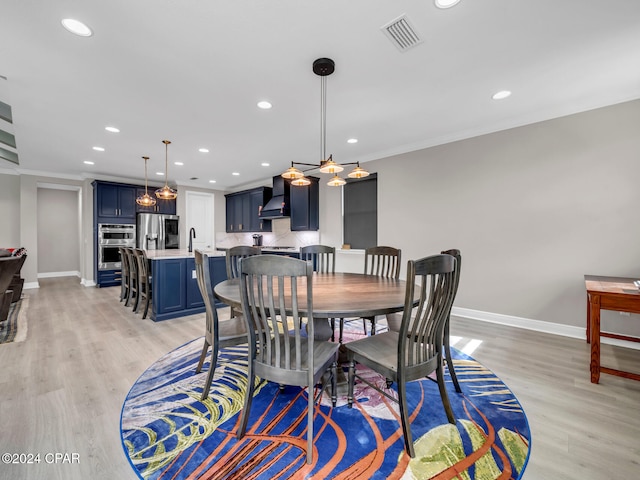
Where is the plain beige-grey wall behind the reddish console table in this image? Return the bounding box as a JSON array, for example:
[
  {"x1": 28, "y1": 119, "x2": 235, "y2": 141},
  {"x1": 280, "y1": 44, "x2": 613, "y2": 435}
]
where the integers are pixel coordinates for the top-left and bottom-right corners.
[{"x1": 321, "y1": 101, "x2": 640, "y2": 335}]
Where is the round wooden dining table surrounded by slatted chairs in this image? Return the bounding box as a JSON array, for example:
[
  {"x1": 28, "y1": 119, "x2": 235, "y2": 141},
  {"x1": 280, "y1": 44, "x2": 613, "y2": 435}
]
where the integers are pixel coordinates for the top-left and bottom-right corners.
[{"x1": 214, "y1": 273, "x2": 420, "y2": 340}]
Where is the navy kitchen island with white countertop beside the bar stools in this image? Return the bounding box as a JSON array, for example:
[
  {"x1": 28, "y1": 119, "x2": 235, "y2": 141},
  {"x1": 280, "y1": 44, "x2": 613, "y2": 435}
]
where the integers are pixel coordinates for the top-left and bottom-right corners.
[{"x1": 146, "y1": 249, "x2": 227, "y2": 322}]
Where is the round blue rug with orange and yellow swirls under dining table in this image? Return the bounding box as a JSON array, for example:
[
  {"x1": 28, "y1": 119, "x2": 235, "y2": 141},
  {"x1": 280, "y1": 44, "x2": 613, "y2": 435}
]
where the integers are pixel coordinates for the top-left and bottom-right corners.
[{"x1": 121, "y1": 332, "x2": 530, "y2": 480}]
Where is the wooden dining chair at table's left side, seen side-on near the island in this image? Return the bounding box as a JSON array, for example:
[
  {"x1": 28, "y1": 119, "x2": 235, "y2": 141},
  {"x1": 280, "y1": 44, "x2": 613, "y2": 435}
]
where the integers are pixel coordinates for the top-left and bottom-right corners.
[{"x1": 194, "y1": 249, "x2": 248, "y2": 400}]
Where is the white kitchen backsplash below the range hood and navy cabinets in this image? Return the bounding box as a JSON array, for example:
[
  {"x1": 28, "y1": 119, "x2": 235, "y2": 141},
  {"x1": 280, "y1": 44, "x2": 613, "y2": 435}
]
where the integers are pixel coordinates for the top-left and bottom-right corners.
[{"x1": 216, "y1": 218, "x2": 320, "y2": 248}]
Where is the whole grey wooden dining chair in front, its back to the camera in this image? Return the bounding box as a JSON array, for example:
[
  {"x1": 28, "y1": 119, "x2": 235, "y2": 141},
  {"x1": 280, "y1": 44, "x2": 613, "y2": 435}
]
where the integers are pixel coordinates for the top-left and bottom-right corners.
[{"x1": 237, "y1": 255, "x2": 339, "y2": 463}]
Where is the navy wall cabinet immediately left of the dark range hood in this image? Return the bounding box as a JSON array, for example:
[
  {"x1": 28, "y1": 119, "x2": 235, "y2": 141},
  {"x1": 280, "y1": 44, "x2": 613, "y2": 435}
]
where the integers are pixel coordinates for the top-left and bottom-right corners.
[{"x1": 225, "y1": 187, "x2": 271, "y2": 233}]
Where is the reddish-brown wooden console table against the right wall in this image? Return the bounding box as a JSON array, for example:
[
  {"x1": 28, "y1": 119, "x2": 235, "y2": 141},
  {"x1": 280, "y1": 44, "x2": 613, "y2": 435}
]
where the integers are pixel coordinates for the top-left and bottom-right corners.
[{"x1": 584, "y1": 275, "x2": 640, "y2": 383}]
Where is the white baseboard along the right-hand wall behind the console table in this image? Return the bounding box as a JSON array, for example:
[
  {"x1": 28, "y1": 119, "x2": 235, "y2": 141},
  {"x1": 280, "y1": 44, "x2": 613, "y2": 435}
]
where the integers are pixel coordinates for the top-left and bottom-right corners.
[{"x1": 451, "y1": 307, "x2": 640, "y2": 350}]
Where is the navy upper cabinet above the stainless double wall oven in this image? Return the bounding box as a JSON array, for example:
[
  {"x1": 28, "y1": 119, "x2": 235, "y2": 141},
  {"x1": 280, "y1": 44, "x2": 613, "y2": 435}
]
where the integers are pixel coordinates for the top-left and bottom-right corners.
[{"x1": 93, "y1": 180, "x2": 136, "y2": 224}]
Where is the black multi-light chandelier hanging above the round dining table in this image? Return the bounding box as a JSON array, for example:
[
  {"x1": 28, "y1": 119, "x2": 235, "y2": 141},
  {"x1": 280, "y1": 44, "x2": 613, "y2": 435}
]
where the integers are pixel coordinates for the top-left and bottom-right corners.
[{"x1": 282, "y1": 58, "x2": 369, "y2": 187}]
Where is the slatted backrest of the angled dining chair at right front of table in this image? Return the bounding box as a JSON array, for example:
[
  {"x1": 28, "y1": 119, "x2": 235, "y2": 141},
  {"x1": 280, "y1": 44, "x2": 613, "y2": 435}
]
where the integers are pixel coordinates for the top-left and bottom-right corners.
[{"x1": 398, "y1": 254, "x2": 456, "y2": 368}]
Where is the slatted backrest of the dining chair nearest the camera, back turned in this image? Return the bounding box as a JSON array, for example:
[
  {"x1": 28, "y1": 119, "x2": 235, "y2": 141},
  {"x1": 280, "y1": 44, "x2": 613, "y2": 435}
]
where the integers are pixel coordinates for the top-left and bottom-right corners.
[{"x1": 240, "y1": 255, "x2": 314, "y2": 378}]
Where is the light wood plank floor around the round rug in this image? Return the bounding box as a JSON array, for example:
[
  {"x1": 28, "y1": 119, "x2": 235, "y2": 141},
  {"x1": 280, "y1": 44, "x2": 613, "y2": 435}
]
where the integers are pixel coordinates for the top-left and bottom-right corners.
[{"x1": 0, "y1": 278, "x2": 640, "y2": 480}]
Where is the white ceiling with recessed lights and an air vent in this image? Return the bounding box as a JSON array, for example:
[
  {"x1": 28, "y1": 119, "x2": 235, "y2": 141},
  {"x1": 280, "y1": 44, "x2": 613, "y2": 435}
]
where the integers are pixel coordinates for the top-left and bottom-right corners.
[{"x1": 0, "y1": 0, "x2": 640, "y2": 190}]
